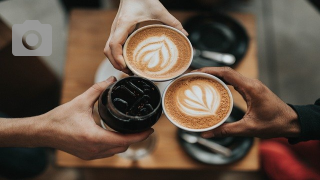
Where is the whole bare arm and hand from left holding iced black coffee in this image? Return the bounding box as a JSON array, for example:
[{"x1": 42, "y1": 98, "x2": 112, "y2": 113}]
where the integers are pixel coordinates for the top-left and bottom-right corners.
[{"x1": 0, "y1": 77, "x2": 153, "y2": 160}]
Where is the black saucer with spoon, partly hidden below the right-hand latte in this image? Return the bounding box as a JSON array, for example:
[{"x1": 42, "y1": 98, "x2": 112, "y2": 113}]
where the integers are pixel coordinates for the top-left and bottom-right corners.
[{"x1": 177, "y1": 106, "x2": 254, "y2": 165}]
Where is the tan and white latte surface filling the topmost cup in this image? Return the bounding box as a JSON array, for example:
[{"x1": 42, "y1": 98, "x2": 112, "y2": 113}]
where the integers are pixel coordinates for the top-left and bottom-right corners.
[{"x1": 123, "y1": 25, "x2": 192, "y2": 81}]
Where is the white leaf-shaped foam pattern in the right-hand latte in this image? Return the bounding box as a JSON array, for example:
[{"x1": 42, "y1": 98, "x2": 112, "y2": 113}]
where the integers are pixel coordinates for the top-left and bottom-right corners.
[{"x1": 177, "y1": 84, "x2": 220, "y2": 116}]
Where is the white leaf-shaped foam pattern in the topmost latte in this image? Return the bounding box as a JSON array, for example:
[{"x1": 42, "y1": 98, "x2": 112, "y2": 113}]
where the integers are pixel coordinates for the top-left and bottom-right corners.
[{"x1": 133, "y1": 35, "x2": 178, "y2": 74}]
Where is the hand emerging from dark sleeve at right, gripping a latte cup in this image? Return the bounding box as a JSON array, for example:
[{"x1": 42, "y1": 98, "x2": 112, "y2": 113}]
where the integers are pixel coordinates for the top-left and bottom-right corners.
[{"x1": 197, "y1": 67, "x2": 300, "y2": 138}]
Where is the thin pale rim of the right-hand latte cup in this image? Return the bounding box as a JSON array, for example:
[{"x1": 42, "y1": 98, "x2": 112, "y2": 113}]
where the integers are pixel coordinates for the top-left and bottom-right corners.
[{"x1": 162, "y1": 72, "x2": 233, "y2": 132}]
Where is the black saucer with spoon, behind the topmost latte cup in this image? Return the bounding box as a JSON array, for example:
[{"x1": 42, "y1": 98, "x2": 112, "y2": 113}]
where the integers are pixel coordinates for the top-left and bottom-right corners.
[{"x1": 184, "y1": 13, "x2": 249, "y2": 69}]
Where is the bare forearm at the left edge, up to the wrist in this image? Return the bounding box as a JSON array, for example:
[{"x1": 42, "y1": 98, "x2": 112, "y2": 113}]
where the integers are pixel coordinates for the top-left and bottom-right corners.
[{"x1": 0, "y1": 115, "x2": 45, "y2": 147}]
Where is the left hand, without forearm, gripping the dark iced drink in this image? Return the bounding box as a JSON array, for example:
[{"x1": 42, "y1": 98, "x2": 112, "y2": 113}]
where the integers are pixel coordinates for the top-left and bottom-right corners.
[{"x1": 40, "y1": 77, "x2": 153, "y2": 160}]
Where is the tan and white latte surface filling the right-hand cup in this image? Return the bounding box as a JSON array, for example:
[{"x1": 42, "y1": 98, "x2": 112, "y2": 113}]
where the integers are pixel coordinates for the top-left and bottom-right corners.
[{"x1": 163, "y1": 73, "x2": 232, "y2": 129}]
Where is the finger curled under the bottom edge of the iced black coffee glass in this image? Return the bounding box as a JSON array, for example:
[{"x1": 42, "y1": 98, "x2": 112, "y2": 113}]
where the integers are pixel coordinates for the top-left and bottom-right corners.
[{"x1": 106, "y1": 129, "x2": 154, "y2": 146}]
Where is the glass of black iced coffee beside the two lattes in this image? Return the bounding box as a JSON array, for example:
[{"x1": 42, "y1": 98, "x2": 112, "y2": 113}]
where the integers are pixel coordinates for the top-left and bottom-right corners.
[{"x1": 98, "y1": 77, "x2": 162, "y2": 133}]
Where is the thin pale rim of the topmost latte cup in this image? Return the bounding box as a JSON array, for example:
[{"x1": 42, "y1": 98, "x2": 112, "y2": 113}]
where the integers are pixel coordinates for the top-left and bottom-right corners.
[{"x1": 123, "y1": 24, "x2": 193, "y2": 82}]
